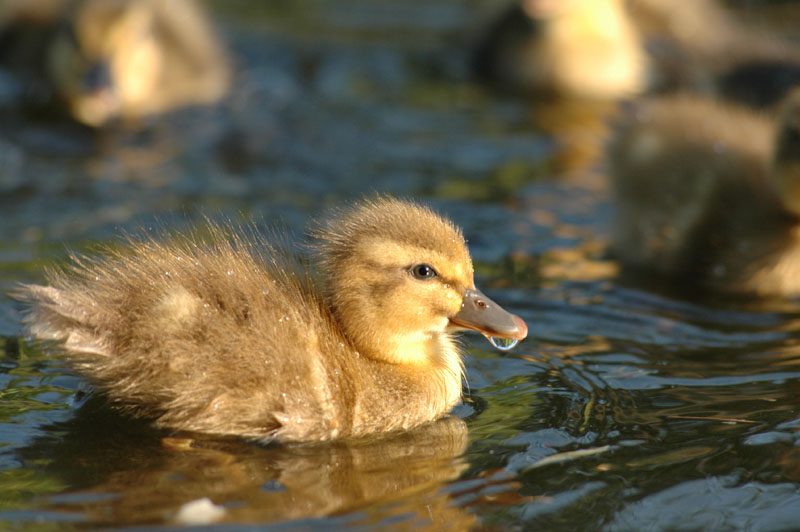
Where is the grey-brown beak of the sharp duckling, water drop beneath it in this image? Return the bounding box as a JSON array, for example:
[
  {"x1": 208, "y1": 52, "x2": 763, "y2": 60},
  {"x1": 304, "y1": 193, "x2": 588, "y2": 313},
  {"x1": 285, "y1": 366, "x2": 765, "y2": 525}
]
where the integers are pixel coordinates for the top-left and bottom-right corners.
[{"x1": 450, "y1": 289, "x2": 528, "y2": 343}]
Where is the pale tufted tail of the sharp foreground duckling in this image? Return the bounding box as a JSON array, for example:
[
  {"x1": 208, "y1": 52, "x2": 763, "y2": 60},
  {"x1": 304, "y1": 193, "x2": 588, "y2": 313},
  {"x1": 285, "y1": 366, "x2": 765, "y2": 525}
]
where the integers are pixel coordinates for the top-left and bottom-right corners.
[{"x1": 10, "y1": 284, "x2": 108, "y2": 356}]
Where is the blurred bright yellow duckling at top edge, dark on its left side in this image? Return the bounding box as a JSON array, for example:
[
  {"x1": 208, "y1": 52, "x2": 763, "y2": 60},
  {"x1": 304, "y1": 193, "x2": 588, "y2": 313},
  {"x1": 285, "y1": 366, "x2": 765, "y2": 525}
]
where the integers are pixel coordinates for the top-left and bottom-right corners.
[{"x1": 474, "y1": 0, "x2": 648, "y2": 99}]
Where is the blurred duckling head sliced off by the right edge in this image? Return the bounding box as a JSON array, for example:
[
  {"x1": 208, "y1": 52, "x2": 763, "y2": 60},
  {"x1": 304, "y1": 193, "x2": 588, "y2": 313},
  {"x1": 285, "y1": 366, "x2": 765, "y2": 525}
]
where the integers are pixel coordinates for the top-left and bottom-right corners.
[{"x1": 772, "y1": 88, "x2": 800, "y2": 216}]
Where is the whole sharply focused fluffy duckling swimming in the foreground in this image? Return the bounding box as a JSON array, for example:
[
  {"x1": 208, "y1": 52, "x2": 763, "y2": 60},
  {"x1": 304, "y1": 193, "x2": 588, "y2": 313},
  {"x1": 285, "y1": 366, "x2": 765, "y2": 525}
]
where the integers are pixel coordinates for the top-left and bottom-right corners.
[{"x1": 16, "y1": 197, "x2": 527, "y2": 442}]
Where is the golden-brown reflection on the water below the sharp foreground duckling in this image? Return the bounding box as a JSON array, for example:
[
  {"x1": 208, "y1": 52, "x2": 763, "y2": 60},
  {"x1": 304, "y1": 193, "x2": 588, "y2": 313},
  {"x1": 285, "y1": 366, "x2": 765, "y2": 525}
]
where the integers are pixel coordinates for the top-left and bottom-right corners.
[{"x1": 20, "y1": 400, "x2": 482, "y2": 530}]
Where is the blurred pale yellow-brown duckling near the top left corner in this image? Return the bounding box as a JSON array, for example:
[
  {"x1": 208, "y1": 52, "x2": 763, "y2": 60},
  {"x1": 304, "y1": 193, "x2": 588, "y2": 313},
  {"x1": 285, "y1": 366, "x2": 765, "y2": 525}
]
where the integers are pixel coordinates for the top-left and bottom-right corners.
[{"x1": 45, "y1": 0, "x2": 229, "y2": 126}]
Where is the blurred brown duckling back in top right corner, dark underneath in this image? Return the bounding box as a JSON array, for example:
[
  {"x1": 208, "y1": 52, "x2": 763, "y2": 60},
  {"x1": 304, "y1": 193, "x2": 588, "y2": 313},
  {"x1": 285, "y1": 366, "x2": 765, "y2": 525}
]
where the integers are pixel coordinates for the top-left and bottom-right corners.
[{"x1": 627, "y1": 0, "x2": 800, "y2": 108}]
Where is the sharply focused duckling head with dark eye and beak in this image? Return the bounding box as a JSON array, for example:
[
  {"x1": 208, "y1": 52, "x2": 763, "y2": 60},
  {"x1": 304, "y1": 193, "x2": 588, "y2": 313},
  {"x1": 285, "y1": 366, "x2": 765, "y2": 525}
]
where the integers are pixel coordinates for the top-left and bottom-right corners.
[{"x1": 314, "y1": 198, "x2": 527, "y2": 365}]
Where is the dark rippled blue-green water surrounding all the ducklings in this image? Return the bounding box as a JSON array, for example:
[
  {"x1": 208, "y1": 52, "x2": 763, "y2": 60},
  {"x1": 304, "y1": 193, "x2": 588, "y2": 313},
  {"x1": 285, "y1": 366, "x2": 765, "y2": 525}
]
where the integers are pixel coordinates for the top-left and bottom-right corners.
[{"x1": 0, "y1": 0, "x2": 800, "y2": 531}]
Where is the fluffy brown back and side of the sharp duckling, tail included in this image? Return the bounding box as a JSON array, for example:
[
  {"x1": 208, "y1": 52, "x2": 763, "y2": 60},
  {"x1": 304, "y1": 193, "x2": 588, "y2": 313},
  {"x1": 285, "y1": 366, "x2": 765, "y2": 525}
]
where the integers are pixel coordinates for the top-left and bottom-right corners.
[{"x1": 18, "y1": 228, "x2": 361, "y2": 441}]
